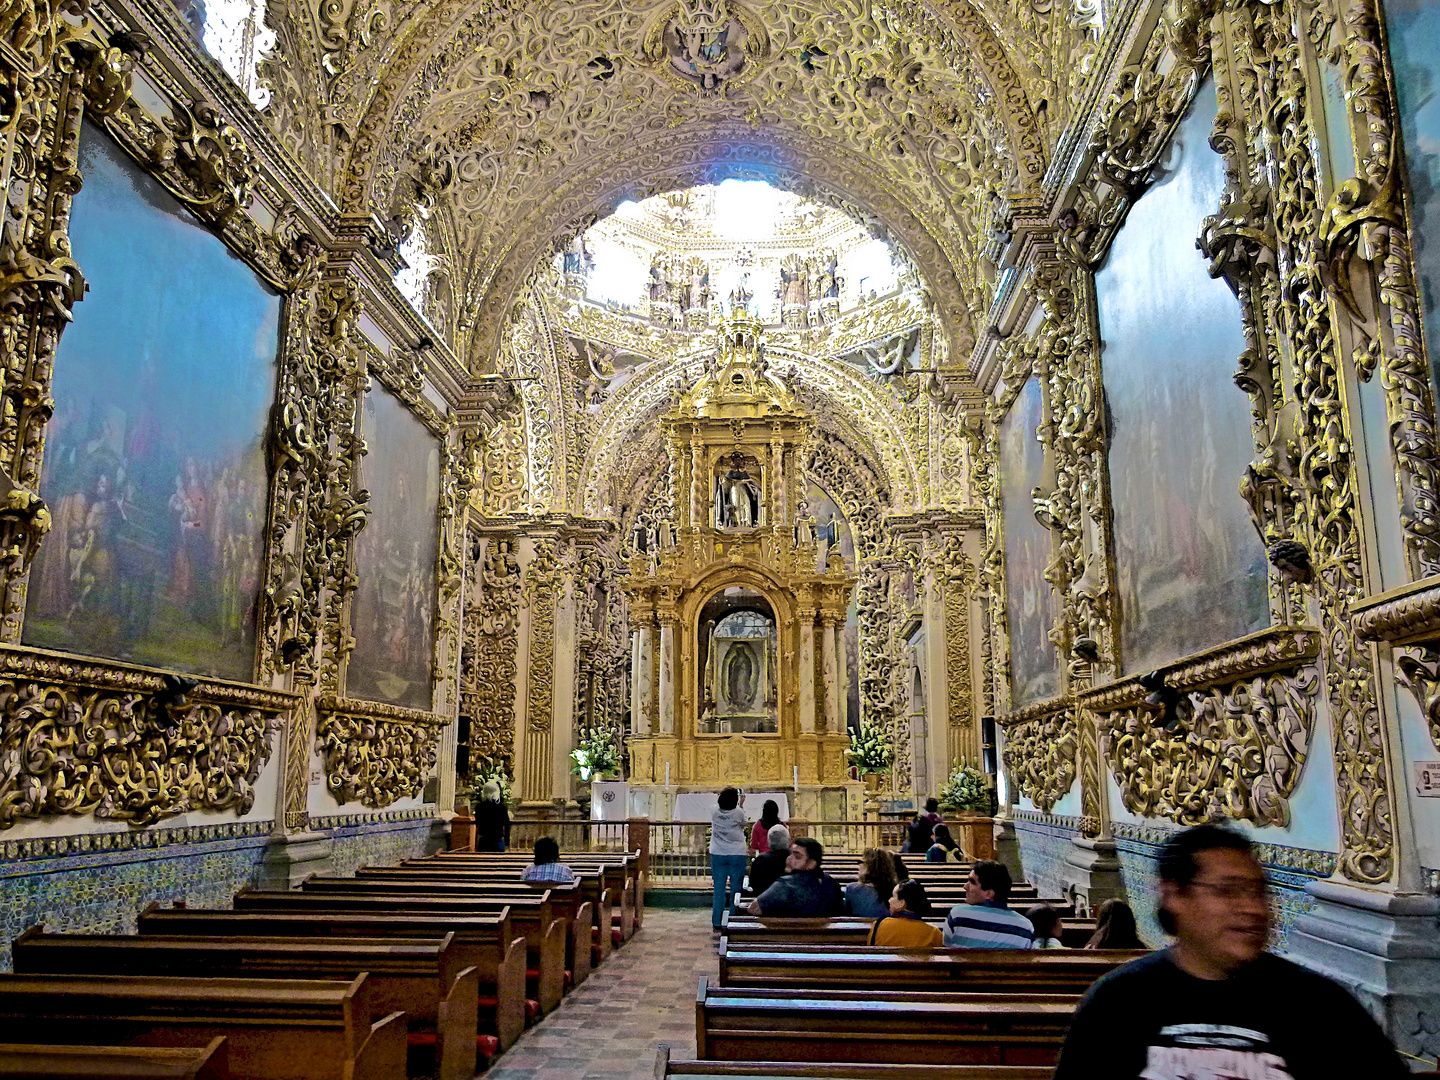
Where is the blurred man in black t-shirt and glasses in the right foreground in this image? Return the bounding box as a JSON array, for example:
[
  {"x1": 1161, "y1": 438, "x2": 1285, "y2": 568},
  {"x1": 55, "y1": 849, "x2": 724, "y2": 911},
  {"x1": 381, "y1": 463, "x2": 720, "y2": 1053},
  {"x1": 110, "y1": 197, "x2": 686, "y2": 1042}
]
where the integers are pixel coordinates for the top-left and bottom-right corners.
[{"x1": 1054, "y1": 825, "x2": 1410, "y2": 1080}]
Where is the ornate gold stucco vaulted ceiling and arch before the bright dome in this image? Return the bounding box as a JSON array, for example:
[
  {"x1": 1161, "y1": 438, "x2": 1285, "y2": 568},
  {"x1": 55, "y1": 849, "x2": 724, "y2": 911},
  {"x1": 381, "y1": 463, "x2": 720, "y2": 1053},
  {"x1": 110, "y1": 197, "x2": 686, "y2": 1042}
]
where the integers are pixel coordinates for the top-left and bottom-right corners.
[{"x1": 264, "y1": 0, "x2": 1093, "y2": 372}]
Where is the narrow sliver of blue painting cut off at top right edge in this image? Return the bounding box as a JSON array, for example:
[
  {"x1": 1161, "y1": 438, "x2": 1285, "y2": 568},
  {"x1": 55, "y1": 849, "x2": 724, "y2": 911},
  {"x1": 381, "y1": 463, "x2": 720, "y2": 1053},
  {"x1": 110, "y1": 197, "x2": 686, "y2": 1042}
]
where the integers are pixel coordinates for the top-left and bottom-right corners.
[{"x1": 1385, "y1": 0, "x2": 1440, "y2": 394}]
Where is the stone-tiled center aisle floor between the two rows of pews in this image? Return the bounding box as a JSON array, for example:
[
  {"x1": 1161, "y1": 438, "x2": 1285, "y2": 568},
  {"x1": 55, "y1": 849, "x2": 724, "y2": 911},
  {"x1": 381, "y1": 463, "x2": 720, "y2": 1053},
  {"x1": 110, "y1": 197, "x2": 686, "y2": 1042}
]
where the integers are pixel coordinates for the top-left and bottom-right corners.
[{"x1": 485, "y1": 907, "x2": 719, "y2": 1080}]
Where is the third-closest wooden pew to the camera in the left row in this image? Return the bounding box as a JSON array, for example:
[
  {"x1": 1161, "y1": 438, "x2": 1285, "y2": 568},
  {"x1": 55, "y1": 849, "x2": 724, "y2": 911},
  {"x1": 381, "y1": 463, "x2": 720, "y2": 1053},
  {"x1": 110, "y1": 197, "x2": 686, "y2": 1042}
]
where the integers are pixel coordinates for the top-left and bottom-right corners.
[{"x1": 14, "y1": 926, "x2": 480, "y2": 1080}]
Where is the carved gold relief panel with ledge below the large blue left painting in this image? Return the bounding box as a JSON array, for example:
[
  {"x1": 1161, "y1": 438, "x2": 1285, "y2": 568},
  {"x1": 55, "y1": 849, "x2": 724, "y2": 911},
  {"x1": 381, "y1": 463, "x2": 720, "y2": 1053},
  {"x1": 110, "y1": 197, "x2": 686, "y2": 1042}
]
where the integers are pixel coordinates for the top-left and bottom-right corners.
[{"x1": 0, "y1": 648, "x2": 297, "y2": 829}]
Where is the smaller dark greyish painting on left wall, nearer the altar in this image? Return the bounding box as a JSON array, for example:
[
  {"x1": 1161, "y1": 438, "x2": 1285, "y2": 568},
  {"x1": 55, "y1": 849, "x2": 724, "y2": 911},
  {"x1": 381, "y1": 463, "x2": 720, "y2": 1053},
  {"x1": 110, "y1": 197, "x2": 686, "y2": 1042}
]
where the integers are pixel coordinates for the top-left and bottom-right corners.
[{"x1": 346, "y1": 386, "x2": 441, "y2": 708}]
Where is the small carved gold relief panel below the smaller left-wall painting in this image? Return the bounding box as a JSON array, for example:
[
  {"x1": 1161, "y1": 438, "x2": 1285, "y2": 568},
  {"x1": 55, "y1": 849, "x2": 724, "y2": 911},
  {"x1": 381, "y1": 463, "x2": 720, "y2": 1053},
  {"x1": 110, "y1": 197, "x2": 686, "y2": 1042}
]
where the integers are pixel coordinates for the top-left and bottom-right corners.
[{"x1": 315, "y1": 696, "x2": 449, "y2": 809}]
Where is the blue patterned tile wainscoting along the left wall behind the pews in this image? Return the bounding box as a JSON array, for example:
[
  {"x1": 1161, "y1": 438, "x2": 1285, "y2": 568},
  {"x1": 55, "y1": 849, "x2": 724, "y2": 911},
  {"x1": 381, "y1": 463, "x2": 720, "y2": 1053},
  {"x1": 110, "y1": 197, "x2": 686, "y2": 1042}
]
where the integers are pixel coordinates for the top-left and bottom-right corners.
[{"x1": 0, "y1": 808, "x2": 433, "y2": 971}]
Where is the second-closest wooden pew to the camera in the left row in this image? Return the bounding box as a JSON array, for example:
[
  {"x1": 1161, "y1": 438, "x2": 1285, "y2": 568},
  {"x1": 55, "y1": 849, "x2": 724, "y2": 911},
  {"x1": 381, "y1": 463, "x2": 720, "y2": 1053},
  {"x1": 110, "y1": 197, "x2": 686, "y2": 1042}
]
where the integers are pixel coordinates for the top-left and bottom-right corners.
[{"x1": 0, "y1": 975, "x2": 406, "y2": 1080}]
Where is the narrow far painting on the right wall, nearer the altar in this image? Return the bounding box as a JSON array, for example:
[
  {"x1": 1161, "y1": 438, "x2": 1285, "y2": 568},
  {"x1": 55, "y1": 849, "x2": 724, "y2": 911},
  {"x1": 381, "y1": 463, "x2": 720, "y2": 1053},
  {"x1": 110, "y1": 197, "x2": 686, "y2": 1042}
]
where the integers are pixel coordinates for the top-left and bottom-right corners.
[{"x1": 999, "y1": 379, "x2": 1060, "y2": 708}]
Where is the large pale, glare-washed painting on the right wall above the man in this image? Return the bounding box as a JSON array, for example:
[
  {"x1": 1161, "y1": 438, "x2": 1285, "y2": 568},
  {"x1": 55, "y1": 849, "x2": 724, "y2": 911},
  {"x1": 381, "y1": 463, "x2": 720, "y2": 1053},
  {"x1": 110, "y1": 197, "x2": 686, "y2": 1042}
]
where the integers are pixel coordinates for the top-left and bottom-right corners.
[{"x1": 1094, "y1": 82, "x2": 1269, "y2": 671}]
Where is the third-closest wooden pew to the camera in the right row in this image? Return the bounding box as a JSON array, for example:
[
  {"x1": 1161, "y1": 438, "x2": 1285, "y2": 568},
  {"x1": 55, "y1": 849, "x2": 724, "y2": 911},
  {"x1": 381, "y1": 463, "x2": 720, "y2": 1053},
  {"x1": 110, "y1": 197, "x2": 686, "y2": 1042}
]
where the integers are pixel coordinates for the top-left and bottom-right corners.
[{"x1": 719, "y1": 940, "x2": 1146, "y2": 994}]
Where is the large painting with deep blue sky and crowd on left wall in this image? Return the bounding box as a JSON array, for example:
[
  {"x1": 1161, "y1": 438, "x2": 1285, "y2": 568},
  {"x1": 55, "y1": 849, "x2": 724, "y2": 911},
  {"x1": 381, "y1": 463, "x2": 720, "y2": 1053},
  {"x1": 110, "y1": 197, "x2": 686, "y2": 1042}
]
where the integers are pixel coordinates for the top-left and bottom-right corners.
[{"x1": 24, "y1": 125, "x2": 279, "y2": 681}]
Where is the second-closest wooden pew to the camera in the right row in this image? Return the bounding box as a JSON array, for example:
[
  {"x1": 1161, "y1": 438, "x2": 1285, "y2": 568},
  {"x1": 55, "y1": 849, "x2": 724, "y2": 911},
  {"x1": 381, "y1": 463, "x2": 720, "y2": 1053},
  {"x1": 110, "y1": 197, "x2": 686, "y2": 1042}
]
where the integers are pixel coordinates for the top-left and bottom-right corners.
[{"x1": 696, "y1": 976, "x2": 1080, "y2": 1067}]
